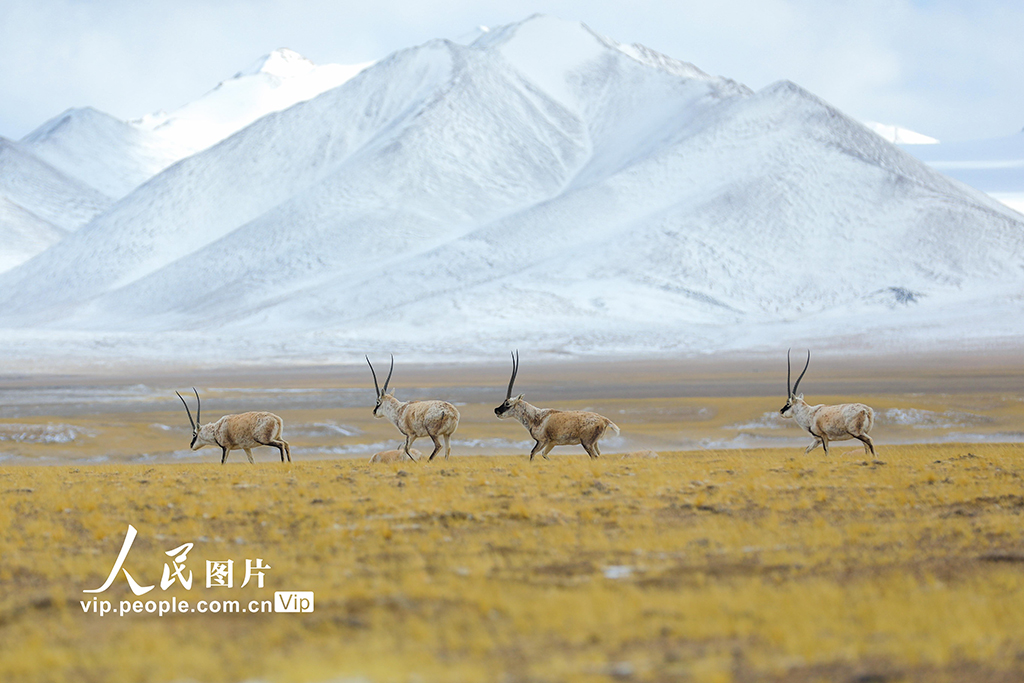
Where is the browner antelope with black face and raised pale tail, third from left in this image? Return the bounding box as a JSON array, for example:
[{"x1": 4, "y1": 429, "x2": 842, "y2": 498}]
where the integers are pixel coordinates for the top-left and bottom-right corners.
[{"x1": 495, "y1": 351, "x2": 618, "y2": 462}]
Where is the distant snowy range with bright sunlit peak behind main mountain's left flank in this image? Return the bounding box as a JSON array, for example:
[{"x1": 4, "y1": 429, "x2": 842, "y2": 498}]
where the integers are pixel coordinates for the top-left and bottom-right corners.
[{"x1": 0, "y1": 48, "x2": 372, "y2": 280}]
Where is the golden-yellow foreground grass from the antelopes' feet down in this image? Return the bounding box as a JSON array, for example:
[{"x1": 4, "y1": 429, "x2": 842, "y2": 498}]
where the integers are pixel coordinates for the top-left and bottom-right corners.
[{"x1": 0, "y1": 446, "x2": 1024, "y2": 682}]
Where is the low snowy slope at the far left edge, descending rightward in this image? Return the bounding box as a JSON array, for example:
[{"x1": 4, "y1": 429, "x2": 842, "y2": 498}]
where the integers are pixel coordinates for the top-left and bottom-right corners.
[{"x1": 0, "y1": 137, "x2": 112, "y2": 271}]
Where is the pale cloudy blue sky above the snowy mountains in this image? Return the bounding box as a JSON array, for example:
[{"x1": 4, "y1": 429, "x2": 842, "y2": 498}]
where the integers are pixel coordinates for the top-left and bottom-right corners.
[{"x1": 0, "y1": 0, "x2": 1024, "y2": 140}]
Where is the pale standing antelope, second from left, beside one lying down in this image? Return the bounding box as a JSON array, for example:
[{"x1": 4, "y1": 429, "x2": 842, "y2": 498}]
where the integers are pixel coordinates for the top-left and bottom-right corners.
[{"x1": 367, "y1": 355, "x2": 459, "y2": 461}]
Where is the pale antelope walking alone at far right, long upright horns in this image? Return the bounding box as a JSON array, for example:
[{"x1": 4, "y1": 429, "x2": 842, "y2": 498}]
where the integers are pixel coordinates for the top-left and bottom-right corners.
[{"x1": 779, "y1": 351, "x2": 874, "y2": 457}]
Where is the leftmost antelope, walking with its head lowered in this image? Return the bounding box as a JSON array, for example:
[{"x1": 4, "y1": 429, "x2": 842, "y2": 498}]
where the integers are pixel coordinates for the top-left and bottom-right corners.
[{"x1": 174, "y1": 387, "x2": 292, "y2": 465}]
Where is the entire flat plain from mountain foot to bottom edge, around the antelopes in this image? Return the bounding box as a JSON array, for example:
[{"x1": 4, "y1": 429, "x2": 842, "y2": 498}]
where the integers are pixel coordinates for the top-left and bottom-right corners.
[{"x1": 0, "y1": 356, "x2": 1024, "y2": 683}]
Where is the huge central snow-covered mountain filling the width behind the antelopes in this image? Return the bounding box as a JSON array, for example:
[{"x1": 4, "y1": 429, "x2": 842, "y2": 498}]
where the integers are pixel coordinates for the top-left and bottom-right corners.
[{"x1": 0, "y1": 16, "x2": 1024, "y2": 368}]
